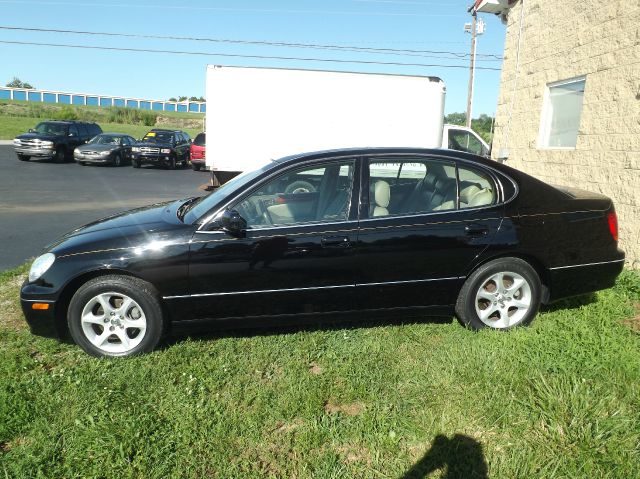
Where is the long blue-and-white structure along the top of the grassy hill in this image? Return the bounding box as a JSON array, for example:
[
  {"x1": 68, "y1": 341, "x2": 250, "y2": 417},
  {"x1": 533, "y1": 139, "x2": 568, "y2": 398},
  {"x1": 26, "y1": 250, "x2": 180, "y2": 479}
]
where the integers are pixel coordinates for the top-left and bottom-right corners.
[{"x1": 0, "y1": 87, "x2": 207, "y2": 113}]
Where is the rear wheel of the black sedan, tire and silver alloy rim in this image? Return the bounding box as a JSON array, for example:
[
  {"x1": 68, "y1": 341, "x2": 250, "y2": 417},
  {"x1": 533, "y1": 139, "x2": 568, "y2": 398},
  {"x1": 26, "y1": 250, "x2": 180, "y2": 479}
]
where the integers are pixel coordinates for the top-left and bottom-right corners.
[{"x1": 455, "y1": 258, "x2": 542, "y2": 331}]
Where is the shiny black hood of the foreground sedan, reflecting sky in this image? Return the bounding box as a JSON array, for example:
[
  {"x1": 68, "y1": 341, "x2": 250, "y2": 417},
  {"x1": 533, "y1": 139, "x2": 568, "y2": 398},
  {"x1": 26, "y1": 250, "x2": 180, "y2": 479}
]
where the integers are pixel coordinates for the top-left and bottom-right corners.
[{"x1": 45, "y1": 200, "x2": 192, "y2": 256}]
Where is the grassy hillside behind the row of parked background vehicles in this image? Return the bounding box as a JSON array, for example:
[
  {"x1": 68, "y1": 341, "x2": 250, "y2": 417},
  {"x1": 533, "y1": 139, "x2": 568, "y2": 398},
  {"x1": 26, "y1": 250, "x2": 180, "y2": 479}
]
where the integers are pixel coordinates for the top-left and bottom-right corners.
[{"x1": 0, "y1": 100, "x2": 204, "y2": 140}]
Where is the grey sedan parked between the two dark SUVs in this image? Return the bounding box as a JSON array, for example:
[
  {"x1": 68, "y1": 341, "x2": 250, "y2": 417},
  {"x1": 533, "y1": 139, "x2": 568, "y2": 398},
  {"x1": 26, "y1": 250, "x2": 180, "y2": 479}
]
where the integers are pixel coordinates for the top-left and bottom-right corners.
[{"x1": 73, "y1": 133, "x2": 136, "y2": 166}]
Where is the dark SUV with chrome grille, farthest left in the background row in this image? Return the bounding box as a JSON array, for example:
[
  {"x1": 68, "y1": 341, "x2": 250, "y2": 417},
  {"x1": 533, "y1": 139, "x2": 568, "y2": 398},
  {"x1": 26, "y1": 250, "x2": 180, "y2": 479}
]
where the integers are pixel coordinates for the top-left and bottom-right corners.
[{"x1": 13, "y1": 120, "x2": 102, "y2": 163}]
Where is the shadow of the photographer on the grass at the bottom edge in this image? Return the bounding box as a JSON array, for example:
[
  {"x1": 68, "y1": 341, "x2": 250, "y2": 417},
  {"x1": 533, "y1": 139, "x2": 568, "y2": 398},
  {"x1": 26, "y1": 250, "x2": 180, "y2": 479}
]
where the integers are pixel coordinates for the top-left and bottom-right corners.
[{"x1": 399, "y1": 434, "x2": 489, "y2": 479}]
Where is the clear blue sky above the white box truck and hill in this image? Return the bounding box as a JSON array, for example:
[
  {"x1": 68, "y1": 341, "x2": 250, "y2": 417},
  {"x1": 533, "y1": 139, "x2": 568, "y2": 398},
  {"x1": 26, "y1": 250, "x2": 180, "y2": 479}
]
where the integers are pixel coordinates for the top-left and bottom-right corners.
[{"x1": 0, "y1": 0, "x2": 505, "y2": 117}]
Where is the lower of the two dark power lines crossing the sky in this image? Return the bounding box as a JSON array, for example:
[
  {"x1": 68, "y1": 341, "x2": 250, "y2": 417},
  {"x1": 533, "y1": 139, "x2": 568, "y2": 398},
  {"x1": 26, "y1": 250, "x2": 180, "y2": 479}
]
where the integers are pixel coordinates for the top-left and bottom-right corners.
[{"x1": 0, "y1": 40, "x2": 500, "y2": 71}]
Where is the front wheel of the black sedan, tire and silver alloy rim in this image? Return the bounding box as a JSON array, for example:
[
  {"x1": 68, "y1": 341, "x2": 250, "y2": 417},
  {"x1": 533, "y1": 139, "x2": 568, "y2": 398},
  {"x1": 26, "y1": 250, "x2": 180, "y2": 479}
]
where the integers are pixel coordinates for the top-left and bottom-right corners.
[{"x1": 67, "y1": 275, "x2": 165, "y2": 357}]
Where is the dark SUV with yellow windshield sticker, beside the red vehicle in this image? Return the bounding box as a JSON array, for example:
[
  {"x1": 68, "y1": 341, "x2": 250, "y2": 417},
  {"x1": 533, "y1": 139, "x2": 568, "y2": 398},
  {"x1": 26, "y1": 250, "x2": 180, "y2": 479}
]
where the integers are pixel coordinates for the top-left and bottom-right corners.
[{"x1": 131, "y1": 128, "x2": 191, "y2": 170}]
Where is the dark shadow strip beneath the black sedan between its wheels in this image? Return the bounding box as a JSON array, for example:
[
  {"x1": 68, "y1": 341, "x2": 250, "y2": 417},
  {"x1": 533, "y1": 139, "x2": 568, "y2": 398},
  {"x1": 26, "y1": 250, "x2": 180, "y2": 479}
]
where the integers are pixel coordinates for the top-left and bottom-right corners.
[{"x1": 158, "y1": 316, "x2": 455, "y2": 349}]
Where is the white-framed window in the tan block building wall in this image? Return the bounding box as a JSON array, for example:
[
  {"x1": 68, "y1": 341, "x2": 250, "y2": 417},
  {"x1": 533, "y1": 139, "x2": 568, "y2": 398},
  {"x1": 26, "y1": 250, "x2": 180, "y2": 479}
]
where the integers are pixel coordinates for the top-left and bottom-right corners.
[{"x1": 538, "y1": 77, "x2": 586, "y2": 148}]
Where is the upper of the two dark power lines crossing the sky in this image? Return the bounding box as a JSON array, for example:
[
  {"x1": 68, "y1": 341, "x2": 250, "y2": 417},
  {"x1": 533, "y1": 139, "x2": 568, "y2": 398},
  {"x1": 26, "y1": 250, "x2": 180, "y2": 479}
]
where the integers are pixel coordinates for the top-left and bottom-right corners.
[{"x1": 0, "y1": 25, "x2": 502, "y2": 61}]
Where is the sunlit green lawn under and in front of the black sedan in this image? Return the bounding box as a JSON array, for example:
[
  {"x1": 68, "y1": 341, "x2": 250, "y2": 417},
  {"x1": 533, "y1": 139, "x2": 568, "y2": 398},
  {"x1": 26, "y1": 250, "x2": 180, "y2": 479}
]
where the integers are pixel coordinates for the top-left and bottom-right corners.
[{"x1": 0, "y1": 267, "x2": 640, "y2": 479}]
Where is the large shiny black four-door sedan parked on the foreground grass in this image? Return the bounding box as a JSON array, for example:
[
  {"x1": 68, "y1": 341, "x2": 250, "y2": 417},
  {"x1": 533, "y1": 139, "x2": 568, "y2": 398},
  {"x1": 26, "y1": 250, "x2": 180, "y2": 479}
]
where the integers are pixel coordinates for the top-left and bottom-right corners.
[{"x1": 21, "y1": 148, "x2": 624, "y2": 356}]
